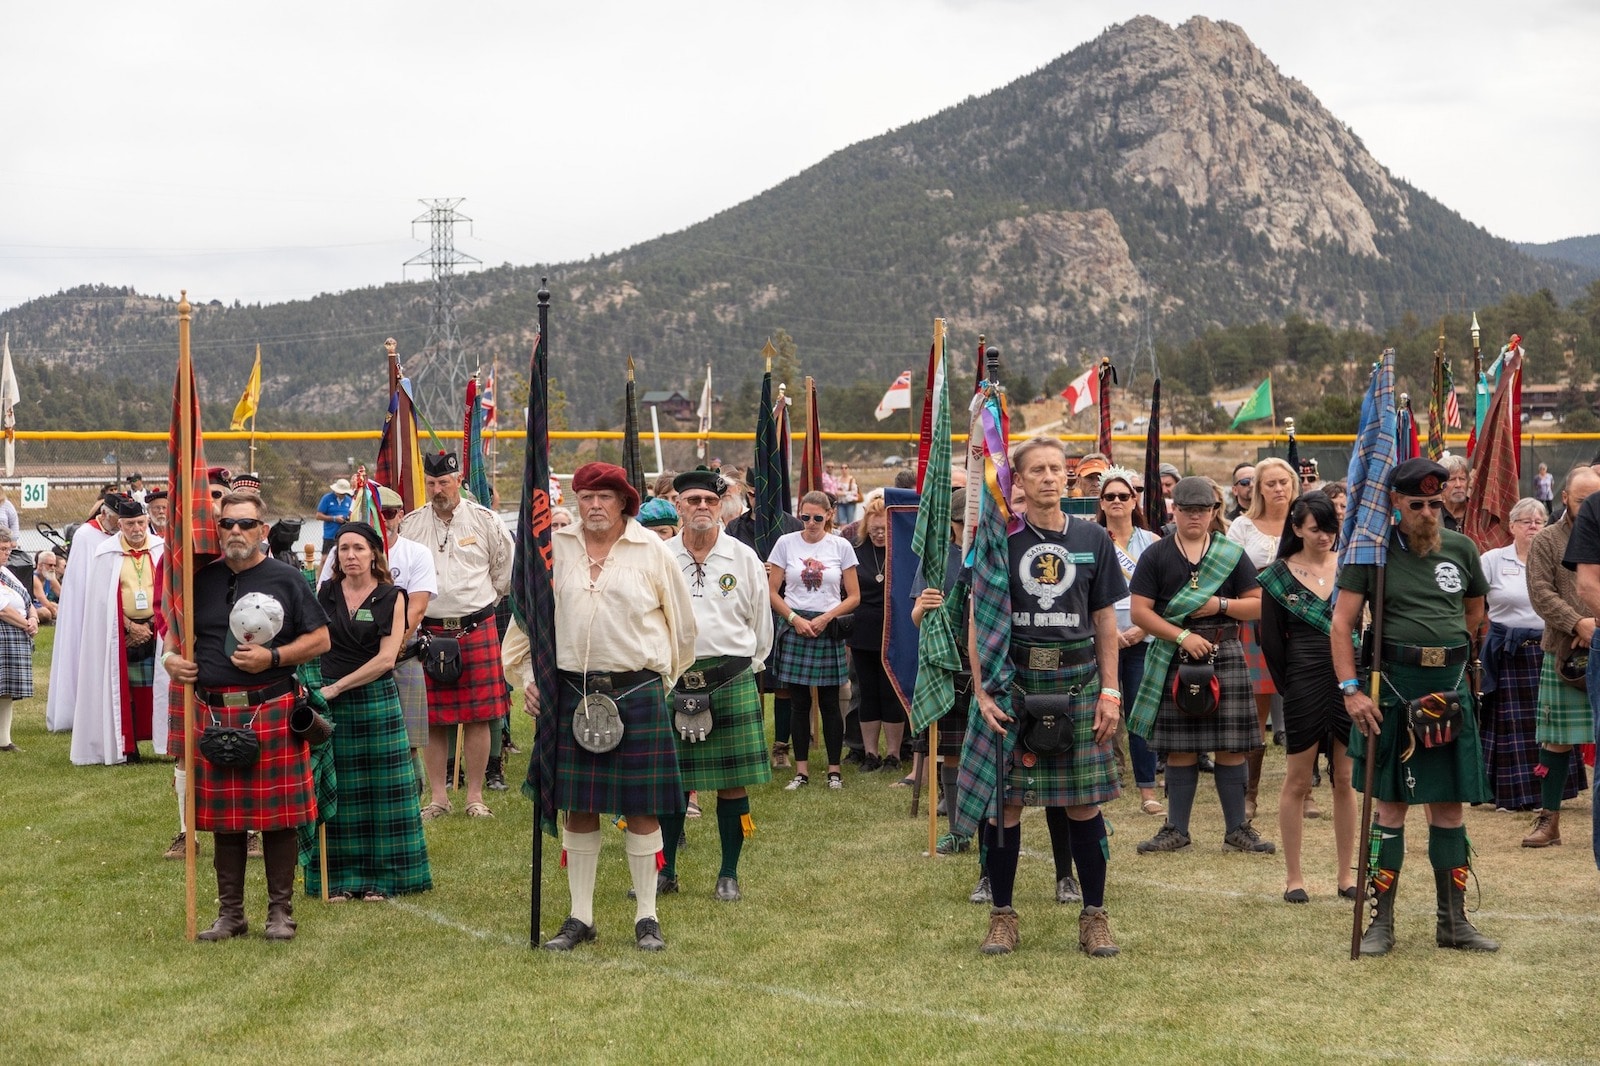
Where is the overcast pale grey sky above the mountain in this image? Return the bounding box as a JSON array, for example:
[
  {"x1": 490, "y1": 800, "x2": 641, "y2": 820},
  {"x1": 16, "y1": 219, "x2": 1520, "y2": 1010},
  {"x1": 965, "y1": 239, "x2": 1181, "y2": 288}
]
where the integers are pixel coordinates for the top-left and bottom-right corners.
[{"x1": 0, "y1": 0, "x2": 1600, "y2": 311}]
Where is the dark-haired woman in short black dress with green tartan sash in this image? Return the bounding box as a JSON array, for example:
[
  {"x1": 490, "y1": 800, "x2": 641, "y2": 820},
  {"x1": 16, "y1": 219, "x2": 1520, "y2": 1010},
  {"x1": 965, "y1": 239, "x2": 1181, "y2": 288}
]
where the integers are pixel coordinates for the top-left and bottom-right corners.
[{"x1": 1259, "y1": 491, "x2": 1355, "y2": 903}]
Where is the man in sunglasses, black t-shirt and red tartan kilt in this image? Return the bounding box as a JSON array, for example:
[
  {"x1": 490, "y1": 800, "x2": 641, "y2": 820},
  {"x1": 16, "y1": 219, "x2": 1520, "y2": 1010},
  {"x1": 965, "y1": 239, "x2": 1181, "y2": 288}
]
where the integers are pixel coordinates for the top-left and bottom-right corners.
[{"x1": 163, "y1": 491, "x2": 328, "y2": 940}]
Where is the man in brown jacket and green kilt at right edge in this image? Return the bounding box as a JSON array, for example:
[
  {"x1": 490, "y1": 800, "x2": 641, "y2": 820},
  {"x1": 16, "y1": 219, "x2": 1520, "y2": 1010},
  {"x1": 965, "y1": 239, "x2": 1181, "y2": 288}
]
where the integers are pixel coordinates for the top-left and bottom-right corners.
[{"x1": 1522, "y1": 466, "x2": 1600, "y2": 848}]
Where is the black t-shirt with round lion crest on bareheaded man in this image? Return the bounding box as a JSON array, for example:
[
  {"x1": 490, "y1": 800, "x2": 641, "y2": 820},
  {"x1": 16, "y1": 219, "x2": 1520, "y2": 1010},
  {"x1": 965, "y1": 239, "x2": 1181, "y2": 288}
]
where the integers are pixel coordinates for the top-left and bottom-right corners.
[{"x1": 1006, "y1": 515, "x2": 1128, "y2": 643}]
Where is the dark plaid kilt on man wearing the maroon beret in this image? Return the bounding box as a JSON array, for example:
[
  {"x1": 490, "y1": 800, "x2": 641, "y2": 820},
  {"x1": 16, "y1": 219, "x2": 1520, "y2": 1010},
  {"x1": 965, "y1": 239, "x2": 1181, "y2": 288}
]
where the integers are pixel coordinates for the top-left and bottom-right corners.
[{"x1": 553, "y1": 674, "x2": 688, "y2": 815}]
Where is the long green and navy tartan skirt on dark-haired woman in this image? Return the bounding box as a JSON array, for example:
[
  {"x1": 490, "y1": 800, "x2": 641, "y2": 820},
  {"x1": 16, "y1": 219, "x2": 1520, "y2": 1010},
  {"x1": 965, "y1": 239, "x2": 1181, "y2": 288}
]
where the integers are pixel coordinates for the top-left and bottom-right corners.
[{"x1": 306, "y1": 677, "x2": 434, "y2": 896}]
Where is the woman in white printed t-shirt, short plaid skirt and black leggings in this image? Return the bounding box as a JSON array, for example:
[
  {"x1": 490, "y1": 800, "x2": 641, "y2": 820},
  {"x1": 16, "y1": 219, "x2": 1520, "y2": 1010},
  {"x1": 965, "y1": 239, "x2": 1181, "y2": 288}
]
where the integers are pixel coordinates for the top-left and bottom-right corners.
[{"x1": 766, "y1": 491, "x2": 861, "y2": 792}]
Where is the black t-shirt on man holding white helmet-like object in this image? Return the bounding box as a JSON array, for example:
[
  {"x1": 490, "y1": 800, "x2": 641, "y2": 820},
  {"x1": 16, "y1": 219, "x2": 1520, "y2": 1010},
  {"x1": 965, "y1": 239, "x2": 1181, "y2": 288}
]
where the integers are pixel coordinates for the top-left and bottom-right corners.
[{"x1": 195, "y1": 559, "x2": 328, "y2": 688}]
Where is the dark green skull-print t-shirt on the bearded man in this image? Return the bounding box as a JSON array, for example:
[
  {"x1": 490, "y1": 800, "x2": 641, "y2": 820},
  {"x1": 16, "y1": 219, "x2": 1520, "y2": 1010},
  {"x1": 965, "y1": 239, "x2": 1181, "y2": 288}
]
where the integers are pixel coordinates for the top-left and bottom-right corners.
[{"x1": 1339, "y1": 530, "x2": 1490, "y2": 648}]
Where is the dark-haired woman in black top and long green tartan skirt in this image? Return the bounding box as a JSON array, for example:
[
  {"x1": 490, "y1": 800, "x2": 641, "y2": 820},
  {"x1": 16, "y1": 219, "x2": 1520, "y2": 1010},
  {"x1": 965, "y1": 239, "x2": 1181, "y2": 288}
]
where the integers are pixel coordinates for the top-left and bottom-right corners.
[{"x1": 306, "y1": 522, "x2": 434, "y2": 903}]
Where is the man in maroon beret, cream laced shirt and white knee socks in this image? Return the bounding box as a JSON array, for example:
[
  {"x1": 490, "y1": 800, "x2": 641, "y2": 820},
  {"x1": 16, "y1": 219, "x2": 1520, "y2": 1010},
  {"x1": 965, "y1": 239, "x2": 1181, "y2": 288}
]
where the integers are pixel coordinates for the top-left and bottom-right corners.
[{"x1": 521, "y1": 463, "x2": 696, "y2": 951}]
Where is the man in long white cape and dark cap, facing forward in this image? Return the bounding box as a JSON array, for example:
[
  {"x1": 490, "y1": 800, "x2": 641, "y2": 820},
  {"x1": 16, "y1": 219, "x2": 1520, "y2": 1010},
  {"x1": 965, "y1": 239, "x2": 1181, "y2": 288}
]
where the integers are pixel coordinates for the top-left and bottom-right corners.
[{"x1": 72, "y1": 496, "x2": 166, "y2": 767}]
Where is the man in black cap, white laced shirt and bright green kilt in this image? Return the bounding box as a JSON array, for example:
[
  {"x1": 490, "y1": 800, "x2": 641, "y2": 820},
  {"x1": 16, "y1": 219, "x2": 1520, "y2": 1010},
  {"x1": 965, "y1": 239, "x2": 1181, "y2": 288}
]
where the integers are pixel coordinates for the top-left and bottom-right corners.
[{"x1": 656, "y1": 467, "x2": 773, "y2": 903}]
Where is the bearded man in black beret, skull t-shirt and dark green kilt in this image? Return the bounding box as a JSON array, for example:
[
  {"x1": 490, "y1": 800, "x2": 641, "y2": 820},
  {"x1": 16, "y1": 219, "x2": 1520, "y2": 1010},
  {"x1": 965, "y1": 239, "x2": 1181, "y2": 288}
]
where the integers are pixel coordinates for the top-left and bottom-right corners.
[{"x1": 1331, "y1": 459, "x2": 1499, "y2": 956}]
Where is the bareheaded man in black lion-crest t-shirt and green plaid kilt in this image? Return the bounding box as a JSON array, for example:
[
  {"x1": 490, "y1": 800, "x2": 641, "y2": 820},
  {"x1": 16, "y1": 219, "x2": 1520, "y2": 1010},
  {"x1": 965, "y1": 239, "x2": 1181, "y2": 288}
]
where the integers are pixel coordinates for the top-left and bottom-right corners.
[{"x1": 952, "y1": 437, "x2": 1128, "y2": 957}]
